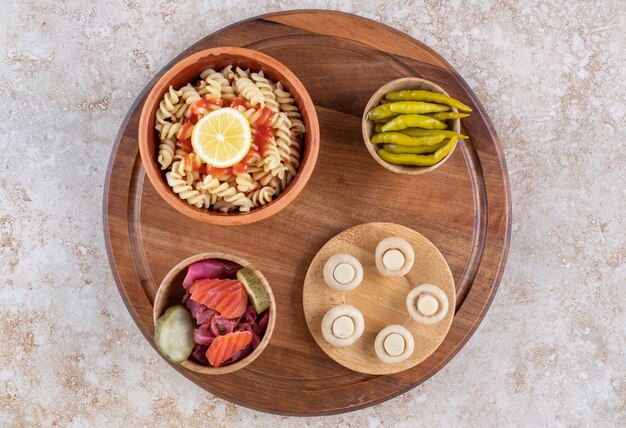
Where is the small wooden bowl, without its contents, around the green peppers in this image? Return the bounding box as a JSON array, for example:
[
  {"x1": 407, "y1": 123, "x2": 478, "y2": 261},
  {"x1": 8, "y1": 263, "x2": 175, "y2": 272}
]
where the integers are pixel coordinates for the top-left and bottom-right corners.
[{"x1": 361, "y1": 77, "x2": 461, "y2": 175}]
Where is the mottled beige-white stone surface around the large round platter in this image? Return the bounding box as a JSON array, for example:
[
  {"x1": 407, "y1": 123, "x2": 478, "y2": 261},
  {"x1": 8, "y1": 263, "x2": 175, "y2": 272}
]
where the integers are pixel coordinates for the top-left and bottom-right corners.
[{"x1": 0, "y1": 0, "x2": 626, "y2": 427}]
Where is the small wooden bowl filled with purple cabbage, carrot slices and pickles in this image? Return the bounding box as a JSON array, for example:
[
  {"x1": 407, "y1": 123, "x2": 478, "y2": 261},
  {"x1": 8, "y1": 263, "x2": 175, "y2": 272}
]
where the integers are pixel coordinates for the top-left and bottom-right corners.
[{"x1": 153, "y1": 252, "x2": 276, "y2": 375}]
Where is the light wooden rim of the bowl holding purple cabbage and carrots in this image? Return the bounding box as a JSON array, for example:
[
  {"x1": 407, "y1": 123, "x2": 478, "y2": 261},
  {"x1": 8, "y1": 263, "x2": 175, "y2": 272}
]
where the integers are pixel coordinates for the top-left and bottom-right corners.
[{"x1": 152, "y1": 251, "x2": 276, "y2": 375}]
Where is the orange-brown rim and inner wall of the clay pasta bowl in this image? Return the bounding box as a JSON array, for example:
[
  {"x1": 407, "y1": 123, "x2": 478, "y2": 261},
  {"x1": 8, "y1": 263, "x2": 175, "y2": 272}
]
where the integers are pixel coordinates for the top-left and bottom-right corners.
[{"x1": 137, "y1": 46, "x2": 320, "y2": 226}]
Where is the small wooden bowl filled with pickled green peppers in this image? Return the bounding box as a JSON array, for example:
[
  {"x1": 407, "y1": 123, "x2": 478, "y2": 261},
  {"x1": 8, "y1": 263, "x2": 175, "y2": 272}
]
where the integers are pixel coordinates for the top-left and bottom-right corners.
[{"x1": 362, "y1": 77, "x2": 472, "y2": 175}]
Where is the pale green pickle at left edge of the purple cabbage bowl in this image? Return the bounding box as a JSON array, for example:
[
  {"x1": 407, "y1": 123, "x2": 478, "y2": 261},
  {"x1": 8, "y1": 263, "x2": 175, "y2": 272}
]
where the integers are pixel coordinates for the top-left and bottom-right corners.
[{"x1": 154, "y1": 305, "x2": 196, "y2": 363}]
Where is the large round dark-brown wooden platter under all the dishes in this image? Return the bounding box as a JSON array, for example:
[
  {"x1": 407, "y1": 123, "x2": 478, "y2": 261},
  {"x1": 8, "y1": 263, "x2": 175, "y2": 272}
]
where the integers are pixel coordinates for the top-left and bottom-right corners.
[{"x1": 103, "y1": 11, "x2": 511, "y2": 415}]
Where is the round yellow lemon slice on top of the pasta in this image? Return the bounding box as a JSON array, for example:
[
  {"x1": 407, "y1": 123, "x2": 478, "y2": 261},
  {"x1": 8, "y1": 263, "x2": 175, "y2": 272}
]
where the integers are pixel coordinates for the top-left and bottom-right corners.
[{"x1": 191, "y1": 108, "x2": 252, "y2": 168}]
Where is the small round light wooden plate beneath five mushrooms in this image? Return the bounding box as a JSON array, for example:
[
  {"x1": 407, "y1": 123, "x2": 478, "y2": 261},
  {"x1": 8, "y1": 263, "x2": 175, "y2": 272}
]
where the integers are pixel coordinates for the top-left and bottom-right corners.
[{"x1": 302, "y1": 223, "x2": 455, "y2": 375}]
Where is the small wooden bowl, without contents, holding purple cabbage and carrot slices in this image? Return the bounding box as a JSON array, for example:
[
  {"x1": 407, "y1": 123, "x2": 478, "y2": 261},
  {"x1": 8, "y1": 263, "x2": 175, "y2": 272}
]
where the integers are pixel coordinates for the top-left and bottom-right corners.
[{"x1": 152, "y1": 252, "x2": 276, "y2": 375}]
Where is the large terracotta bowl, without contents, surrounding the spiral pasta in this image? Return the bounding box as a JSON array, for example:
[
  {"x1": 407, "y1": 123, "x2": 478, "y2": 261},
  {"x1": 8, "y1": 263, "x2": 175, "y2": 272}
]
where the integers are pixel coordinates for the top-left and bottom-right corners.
[{"x1": 139, "y1": 47, "x2": 320, "y2": 226}]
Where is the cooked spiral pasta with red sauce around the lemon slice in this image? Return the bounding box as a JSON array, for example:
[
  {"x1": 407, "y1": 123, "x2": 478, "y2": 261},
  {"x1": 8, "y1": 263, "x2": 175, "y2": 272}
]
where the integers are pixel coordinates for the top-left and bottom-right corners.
[{"x1": 155, "y1": 65, "x2": 306, "y2": 213}]
